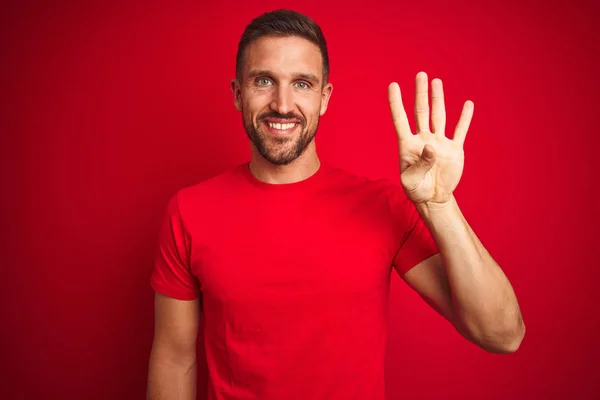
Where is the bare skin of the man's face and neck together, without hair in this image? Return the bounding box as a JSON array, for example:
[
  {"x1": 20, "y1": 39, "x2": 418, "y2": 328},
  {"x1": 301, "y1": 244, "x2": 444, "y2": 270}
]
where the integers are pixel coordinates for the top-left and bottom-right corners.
[{"x1": 231, "y1": 36, "x2": 333, "y2": 183}]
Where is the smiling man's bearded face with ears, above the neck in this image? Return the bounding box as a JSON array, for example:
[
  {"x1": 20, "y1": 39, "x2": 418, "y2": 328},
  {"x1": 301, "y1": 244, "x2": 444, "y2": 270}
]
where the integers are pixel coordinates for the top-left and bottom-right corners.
[{"x1": 231, "y1": 36, "x2": 332, "y2": 165}]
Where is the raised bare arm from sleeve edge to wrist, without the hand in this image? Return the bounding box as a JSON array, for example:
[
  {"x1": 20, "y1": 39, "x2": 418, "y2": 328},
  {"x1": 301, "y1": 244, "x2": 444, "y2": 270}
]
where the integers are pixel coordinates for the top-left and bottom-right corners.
[{"x1": 403, "y1": 197, "x2": 525, "y2": 353}]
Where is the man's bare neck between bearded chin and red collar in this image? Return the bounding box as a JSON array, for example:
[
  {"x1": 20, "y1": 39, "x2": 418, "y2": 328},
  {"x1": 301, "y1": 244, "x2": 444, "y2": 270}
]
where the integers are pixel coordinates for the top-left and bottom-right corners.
[{"x1": 250, "y1": 140, "x2": 321, "y2": 184}]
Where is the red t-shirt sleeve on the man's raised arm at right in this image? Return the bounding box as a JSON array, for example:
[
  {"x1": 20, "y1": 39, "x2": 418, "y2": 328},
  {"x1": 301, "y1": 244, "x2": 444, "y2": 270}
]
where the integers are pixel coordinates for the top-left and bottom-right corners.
[{"x1": 388, "y1": 185, "x2": 439, "y2": 276}]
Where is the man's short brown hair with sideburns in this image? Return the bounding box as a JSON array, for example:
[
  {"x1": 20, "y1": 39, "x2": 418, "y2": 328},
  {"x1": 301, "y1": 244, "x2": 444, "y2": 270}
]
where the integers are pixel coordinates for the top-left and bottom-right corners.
[{"x1": 235, "y1": 10, "x2": 329, "y2": 84}]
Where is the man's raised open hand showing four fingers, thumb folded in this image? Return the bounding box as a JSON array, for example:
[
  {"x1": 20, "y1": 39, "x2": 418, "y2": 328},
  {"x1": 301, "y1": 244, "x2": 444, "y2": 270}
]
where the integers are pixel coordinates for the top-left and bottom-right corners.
[{"x1": 388, "y1": 72, "x2": 473, "y2": 203}]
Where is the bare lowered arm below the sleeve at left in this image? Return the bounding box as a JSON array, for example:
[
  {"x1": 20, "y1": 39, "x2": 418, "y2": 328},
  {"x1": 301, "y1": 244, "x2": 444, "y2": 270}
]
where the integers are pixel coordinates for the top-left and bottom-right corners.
[{"x1": 146, "y1": 292, "x2": 199, "y2": 400}]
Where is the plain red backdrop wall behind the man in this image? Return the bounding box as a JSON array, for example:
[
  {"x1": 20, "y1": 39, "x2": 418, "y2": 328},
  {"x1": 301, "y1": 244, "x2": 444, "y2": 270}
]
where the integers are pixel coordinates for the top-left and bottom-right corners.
[{"x1": 0, "y1": 0, "x2": 600, "y2": 399}]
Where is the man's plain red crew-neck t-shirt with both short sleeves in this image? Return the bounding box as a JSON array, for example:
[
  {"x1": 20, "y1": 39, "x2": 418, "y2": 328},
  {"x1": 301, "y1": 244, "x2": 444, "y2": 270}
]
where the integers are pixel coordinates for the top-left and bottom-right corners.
[{"x1": 151, "y1": 162, "x2": 438, "y2": 400}]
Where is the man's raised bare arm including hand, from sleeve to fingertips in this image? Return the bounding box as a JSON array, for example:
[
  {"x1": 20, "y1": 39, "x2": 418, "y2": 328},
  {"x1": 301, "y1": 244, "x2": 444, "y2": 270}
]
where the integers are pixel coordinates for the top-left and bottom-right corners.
[{"x1": 388, "y1": 72, "x2": 525, "y2": 353}]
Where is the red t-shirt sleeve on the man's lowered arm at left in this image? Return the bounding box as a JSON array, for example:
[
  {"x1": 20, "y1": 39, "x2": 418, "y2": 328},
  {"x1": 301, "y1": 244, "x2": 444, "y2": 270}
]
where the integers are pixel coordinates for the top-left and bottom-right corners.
[{"x1": 150, "y1": 195, "x2": 199, "y2": 300}]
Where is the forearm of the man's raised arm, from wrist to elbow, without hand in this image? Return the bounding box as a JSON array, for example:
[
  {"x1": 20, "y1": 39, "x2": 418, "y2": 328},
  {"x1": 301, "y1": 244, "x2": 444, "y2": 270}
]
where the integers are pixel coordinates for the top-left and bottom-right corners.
[{"x1": 417, "y1": 197, "x2": 525, "y2": 352}]
